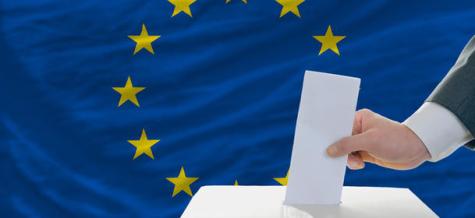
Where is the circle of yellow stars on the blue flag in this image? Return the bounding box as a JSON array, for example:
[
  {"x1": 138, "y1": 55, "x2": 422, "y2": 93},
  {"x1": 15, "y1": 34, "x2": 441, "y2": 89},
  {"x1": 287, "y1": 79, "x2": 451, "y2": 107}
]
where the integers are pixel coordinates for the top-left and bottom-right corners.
[{"x1": 112, "y1": 0, "x2": 346, "y2": 197}]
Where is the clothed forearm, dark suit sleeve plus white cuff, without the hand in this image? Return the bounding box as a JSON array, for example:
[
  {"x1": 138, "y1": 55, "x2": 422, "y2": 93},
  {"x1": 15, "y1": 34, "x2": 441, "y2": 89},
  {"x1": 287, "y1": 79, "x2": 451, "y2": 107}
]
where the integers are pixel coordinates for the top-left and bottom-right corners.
[{"x1": 404, "y1": 36, "x2": 475, "y2": 161}]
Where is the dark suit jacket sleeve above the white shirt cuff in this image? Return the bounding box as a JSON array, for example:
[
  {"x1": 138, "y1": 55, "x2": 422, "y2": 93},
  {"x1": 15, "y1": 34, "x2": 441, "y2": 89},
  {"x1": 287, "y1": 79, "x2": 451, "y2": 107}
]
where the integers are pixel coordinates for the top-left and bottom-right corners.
[{"x1": 427, "y1": 36, "x2": 475, "y2": 149}]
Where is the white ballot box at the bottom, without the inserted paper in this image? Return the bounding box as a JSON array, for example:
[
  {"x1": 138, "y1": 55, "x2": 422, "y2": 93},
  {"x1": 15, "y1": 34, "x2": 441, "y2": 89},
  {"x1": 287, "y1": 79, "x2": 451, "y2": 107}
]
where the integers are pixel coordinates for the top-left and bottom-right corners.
[{"x1": 182, "y1": 186, "x2": 438, "y2": 218}]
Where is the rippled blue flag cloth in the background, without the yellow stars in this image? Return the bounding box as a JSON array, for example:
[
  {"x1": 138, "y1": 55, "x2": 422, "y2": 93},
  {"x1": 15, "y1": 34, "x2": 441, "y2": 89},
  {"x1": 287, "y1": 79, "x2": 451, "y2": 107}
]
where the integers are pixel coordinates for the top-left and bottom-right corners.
[{"x1": 0, "y1": 0, "x2": 475, "y2": 217}]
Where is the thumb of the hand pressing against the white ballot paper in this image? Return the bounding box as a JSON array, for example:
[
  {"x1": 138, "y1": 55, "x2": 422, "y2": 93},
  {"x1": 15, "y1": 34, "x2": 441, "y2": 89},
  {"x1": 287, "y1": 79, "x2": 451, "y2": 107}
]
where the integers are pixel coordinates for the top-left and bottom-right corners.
[{"x1": 327, "y1": 133, "x2": 371, "y2": 157}]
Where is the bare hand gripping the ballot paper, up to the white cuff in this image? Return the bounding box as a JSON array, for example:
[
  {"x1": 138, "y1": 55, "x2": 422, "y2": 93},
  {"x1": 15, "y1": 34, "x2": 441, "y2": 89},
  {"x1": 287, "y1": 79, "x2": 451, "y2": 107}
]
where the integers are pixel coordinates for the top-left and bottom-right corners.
[{"x1": 327, "y1": 109, "x2": 430, "y2": 170}]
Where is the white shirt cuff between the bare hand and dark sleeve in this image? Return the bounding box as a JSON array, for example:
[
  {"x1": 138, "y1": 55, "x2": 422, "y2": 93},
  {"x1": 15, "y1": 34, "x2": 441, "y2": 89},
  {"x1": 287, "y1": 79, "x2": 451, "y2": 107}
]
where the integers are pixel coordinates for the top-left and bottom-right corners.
[{"x1": 403, "y1": 102, "x2": 473, "y2": 162}]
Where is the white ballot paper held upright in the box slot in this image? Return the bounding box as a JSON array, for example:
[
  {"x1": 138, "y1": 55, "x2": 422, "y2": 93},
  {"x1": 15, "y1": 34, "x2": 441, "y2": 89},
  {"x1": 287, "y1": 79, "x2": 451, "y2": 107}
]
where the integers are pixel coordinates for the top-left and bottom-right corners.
[{"x1": 285, "y1": 71, "x2": 360, "y2": 205}]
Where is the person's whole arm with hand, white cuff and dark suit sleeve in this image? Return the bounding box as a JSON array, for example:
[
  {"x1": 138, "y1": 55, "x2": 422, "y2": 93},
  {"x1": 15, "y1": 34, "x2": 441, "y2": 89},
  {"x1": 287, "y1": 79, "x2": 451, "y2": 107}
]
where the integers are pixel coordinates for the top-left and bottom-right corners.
[{"x1": 327, "y1": 36, "x2": 475, "y2": 170}]
